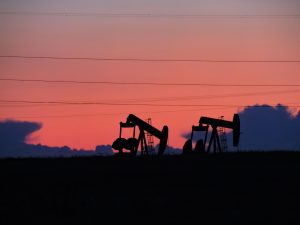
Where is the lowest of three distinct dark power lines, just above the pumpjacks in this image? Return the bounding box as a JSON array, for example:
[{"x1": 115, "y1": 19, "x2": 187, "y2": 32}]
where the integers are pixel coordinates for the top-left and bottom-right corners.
[{"x1": 0, "y1": 100, "x2": 300, "y2": 108}]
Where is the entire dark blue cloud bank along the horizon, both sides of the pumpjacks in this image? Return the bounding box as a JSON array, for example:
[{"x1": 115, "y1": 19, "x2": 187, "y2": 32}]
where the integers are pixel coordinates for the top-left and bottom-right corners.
[{"x1": 0, "y1": 105, "x2": 300, "y2": 157}]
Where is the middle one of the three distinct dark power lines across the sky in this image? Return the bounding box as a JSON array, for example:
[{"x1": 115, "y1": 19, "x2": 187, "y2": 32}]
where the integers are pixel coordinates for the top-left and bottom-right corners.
[{"x1": 0, "y1": 78, "x2": 300, "y2": 87}]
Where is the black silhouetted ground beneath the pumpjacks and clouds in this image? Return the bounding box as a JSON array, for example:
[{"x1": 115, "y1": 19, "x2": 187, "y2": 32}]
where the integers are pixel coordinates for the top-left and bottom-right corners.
[{"x1": 0, "y1": 152, "x2": 300, "y2": 225}]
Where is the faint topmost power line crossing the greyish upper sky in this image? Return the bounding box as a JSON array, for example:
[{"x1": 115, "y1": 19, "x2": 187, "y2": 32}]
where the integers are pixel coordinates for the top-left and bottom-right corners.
[{"x1": 0, "y1": 11, "x2": 300, "y2": 19}]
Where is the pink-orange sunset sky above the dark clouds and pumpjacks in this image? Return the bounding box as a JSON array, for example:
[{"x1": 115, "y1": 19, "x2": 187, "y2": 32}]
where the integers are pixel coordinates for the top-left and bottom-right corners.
[{"x1": 0, "y1": 1, "x2": 300, "y2": 149}]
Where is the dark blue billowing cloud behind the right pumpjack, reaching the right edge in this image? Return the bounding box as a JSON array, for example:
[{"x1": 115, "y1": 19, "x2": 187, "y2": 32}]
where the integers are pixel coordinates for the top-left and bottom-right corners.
[{"x1": 183, "y1": 105, "x2": 300, "y2": 151}]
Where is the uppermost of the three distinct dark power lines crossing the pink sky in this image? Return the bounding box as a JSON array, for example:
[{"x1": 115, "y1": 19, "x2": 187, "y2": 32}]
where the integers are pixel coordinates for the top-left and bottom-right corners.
[{"x1": 0, "y1": 55, "x2": 300, "y2": 63}]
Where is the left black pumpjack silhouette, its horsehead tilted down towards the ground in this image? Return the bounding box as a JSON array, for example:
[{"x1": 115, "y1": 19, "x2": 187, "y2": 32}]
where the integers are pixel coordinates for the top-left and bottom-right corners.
[{"x1": 112, "y1": 114, "x2": 169, "y2": 156}]
